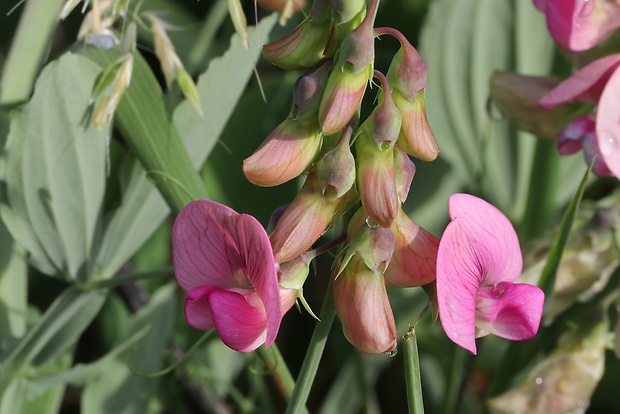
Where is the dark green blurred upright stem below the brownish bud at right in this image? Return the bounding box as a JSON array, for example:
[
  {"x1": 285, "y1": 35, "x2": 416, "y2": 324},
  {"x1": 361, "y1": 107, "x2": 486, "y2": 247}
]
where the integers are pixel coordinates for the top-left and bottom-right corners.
[{"x1": 519, "y1": 139, "x2": 557, "y2": 242}]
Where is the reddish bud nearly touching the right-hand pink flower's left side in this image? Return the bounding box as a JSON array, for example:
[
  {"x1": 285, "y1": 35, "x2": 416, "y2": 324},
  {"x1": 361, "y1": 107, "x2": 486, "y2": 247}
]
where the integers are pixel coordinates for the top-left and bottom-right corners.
[{"x1": 385, "y1": 209, "x2": 439, "y2": 287}]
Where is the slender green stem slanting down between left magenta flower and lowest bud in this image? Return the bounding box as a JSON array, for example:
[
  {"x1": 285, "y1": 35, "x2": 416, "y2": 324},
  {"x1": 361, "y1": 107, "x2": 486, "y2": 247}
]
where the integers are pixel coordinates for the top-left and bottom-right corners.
[{"x1": 286, "y1": 278, "x2": 336, "y2": 414}]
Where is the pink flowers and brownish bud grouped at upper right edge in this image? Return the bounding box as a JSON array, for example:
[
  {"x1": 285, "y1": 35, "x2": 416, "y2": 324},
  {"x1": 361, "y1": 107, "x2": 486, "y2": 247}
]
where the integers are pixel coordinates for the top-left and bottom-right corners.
[{"x1": 491, "y1": 0, "x2": 620, "y2": 179}]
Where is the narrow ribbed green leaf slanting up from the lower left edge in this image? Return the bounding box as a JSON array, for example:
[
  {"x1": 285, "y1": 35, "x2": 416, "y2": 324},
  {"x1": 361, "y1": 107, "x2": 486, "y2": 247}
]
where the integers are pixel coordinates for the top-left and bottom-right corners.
[{"x1": 0, "y1": 288, "x2": 106, "y2": 390}]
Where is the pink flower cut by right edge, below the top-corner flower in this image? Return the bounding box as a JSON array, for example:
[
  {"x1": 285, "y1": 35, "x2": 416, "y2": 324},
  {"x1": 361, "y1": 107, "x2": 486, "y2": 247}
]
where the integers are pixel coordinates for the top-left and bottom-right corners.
[{"x1": 538, "y1": 54, "x2": 620, "y2": 178}]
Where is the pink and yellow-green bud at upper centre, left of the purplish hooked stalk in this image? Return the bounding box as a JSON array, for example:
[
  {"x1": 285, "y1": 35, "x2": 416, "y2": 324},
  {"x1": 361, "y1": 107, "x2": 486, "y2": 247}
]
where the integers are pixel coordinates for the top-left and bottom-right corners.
[{"x1": 319, "y1": 64, "x2": 372, "y2": 135}]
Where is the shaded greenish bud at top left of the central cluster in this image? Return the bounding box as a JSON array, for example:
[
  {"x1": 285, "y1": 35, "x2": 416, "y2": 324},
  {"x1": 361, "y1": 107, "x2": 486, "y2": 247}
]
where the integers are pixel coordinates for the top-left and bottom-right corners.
[{"x1": 263, "y1": 0, "x2": 331, "y2": 70}]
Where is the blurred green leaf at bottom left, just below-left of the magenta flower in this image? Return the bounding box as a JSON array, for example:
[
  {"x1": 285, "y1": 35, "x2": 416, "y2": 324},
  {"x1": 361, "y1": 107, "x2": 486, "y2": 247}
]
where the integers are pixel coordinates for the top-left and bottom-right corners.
[{"x1": 82, "y1": 283, "x2": 177, "y2": 414}]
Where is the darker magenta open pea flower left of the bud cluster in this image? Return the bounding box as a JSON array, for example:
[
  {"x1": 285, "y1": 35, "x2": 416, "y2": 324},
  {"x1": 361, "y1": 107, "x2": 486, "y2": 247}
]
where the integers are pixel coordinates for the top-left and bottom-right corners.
[{"x1": 172, "y1": 200, "x2": 284, "y2": 352}]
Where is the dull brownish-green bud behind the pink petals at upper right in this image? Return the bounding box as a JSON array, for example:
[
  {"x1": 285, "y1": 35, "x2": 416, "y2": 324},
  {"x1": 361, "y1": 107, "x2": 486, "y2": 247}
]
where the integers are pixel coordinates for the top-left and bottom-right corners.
[{"x1": 491, "y1": 71, "x2": 575, "y2": 138}]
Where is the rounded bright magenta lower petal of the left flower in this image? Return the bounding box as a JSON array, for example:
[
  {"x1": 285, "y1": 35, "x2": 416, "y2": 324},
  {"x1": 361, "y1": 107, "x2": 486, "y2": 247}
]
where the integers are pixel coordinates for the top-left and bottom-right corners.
[{"x1": 208, "y1": 290, "x2": 267, "y2": 352}]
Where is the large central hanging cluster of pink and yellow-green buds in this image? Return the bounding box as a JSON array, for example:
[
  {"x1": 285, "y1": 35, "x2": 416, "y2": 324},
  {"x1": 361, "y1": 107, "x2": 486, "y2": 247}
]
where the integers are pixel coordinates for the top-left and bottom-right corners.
[{"x1": 243, "y1": 0, "x2": 439, "y2": 354}]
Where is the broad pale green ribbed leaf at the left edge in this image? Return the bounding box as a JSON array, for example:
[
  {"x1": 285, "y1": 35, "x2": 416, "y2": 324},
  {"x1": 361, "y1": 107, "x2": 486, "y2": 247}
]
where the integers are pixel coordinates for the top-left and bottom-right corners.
[{"x1": 0, "y1": 54, "x2": 106, "y2": 281}]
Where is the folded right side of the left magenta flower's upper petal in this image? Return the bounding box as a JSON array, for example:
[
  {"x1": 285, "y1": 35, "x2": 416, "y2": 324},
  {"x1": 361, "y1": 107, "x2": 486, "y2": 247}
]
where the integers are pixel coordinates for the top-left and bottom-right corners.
[{"x1": 236, "y1": 214, "x2": 282, "y2": 346}]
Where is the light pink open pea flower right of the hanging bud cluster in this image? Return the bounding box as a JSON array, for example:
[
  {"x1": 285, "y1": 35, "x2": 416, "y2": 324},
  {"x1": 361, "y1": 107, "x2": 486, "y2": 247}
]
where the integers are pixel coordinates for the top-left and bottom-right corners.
[{"x1": 437, "y1": 194, "x2": 545, "y2": 354}]
